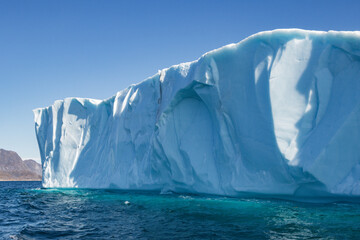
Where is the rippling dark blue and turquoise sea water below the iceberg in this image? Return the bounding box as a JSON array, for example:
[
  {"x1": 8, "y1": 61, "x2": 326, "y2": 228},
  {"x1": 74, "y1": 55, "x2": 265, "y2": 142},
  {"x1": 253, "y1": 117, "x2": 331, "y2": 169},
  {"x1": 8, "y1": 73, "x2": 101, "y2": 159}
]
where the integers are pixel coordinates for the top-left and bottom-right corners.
[{"x1": 0, "y1": 182, "x2": 360, "y2": 240}]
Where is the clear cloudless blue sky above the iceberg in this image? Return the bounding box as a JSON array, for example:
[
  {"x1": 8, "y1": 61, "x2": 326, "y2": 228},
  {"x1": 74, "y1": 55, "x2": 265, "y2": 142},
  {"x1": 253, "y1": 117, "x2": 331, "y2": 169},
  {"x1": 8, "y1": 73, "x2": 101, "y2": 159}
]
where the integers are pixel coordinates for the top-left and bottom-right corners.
[{"x1": 0, "y1": 0, "x2": 360, "y2": 159}]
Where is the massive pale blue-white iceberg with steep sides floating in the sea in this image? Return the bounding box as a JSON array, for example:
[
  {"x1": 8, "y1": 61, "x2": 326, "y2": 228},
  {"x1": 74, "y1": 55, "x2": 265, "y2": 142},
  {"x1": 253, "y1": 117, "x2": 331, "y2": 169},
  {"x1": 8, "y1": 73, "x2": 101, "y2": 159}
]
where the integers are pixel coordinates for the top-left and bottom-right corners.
[{"x1": 34, "y1": 30, "x2": 360, "y2": 196}]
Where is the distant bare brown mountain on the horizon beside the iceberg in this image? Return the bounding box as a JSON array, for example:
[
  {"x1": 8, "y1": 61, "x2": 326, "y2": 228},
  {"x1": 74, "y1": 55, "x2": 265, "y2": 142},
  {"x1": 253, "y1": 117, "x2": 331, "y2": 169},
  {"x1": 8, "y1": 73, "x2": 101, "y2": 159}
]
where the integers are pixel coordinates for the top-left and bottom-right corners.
[{"x1": 0, "y1": 149, "x2": 41, "y2": 181}]
